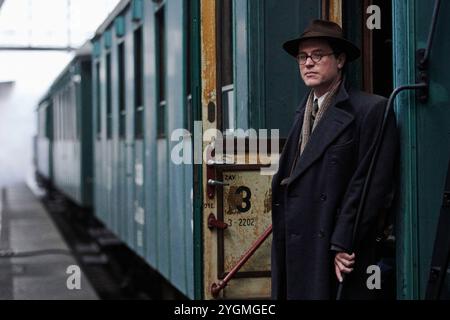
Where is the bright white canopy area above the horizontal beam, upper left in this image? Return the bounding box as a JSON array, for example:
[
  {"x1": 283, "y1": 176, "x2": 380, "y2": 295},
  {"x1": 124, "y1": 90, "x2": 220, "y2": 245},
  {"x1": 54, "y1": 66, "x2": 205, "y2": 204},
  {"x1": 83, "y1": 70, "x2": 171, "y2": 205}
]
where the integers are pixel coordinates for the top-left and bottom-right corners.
[{"x1": 0, "y1": 0, "x2": 119, "y2": 50}]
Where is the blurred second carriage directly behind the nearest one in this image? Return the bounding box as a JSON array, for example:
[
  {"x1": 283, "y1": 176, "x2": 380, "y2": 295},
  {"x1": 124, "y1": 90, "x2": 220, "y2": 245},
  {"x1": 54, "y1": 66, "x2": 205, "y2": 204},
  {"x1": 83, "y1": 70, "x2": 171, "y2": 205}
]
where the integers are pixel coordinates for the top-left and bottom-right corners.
[{"x1": 49, "y1": 56, "x2": 92, "y2": 207}]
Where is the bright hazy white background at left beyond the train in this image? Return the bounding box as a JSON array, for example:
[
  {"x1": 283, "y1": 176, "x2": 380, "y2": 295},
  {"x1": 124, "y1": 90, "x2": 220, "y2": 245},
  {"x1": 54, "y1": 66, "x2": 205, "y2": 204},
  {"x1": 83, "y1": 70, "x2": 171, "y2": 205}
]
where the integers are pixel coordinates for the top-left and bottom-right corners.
[{"x1": 0, "y1": 0, "x2": 119, "y2": 188}]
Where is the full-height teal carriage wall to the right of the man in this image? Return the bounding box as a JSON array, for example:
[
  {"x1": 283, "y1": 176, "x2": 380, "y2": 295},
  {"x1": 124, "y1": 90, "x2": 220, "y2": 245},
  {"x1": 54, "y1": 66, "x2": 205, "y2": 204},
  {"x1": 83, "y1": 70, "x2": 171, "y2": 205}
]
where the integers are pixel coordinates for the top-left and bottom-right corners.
[{"x1": 393, "y1": 0, "x2": 450, "y2": 299}]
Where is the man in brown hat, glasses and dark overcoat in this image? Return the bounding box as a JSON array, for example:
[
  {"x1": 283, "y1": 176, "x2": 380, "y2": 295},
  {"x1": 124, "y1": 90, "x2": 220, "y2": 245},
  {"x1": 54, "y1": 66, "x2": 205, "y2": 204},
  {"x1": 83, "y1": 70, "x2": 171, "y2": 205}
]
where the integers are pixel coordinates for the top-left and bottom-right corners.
[{"x1": 272, "y1": 20, "x2": 398, "y2": 299}]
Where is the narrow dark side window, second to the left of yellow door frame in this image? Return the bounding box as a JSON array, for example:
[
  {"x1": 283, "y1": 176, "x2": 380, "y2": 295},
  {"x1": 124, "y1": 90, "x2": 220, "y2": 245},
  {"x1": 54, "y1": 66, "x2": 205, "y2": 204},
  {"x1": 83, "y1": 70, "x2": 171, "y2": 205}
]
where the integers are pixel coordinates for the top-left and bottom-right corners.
[{"x1": 134, "y1": 26, "x2": 144, "y2": 139}]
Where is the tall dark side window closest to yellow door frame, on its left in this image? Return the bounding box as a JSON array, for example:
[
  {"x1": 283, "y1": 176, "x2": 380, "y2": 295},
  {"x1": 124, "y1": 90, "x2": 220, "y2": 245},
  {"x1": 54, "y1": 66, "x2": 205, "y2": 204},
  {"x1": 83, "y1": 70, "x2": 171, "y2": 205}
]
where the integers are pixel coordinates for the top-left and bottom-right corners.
[{"x1": 155, "y1": 3, "x2": 167, "y2": 138}]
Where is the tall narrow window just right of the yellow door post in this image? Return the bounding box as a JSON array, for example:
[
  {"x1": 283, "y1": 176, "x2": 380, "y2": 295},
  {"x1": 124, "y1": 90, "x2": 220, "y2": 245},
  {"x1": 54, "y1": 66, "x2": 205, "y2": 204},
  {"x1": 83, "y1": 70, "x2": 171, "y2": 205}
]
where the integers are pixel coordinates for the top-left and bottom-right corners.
[{"x1": 216, "y1": 0, "x2": 236, "y2": 132}]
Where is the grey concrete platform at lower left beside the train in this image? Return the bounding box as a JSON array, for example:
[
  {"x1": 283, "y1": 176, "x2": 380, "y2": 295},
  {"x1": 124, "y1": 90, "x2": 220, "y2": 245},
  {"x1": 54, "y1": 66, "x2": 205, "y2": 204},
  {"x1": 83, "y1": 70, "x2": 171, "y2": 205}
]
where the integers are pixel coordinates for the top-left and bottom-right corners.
[{"x1": 0, "y1": 184, "x2": 98, "y2": 300}]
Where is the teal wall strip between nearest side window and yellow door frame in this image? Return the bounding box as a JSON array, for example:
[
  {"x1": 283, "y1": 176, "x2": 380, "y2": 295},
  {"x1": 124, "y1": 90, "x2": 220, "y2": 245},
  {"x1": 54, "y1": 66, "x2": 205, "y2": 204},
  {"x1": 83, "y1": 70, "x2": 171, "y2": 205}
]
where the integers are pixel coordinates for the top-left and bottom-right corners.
[{"x1": 165, "y1": 1, "x2": 193, "y2": 295}]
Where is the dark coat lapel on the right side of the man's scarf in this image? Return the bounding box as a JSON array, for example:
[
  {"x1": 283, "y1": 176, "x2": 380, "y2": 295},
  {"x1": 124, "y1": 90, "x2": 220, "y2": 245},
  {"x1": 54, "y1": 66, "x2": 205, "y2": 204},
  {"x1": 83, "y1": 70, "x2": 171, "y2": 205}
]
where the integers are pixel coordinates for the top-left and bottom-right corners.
[{"x1": 289, "y1": 86, "x2": 354, "y2": 184}]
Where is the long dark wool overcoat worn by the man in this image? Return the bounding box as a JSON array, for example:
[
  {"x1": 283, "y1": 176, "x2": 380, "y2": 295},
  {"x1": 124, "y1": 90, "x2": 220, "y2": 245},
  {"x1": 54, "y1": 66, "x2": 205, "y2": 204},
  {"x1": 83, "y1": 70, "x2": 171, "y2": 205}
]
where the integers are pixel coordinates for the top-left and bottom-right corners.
[{"x1": 272, "y1": 81, "x2": 398, "y2": 299}]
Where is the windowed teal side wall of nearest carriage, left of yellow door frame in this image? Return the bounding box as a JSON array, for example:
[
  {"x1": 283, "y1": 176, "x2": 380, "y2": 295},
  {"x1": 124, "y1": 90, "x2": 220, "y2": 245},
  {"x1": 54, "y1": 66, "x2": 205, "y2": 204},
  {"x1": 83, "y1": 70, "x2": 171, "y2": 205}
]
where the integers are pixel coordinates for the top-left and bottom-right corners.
[{"x1": 93, "y1": 1, "x2": 195, "y2": 298}]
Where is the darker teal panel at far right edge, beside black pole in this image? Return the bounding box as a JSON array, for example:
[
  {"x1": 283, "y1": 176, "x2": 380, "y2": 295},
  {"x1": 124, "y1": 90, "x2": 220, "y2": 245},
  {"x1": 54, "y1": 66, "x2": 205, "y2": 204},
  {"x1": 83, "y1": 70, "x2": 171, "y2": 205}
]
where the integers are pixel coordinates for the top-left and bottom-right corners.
[{"x1": 416, "y1": 0, "x2": 450, "y2": 299}]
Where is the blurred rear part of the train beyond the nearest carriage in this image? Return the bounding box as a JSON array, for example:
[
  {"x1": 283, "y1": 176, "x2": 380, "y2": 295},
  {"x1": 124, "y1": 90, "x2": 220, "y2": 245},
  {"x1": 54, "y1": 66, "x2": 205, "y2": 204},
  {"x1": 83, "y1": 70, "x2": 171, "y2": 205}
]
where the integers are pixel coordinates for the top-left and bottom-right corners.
[{"x1": 37, "y1": 43, "x2": 93, "y2": 209}]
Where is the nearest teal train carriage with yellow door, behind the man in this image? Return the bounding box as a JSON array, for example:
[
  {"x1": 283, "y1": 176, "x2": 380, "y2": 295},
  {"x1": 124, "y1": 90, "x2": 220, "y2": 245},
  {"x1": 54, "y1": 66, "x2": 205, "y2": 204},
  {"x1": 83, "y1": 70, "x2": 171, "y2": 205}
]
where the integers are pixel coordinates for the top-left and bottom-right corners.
[{"x1": 35, "y1": 0, "x2": 450, "y2": 299}]
